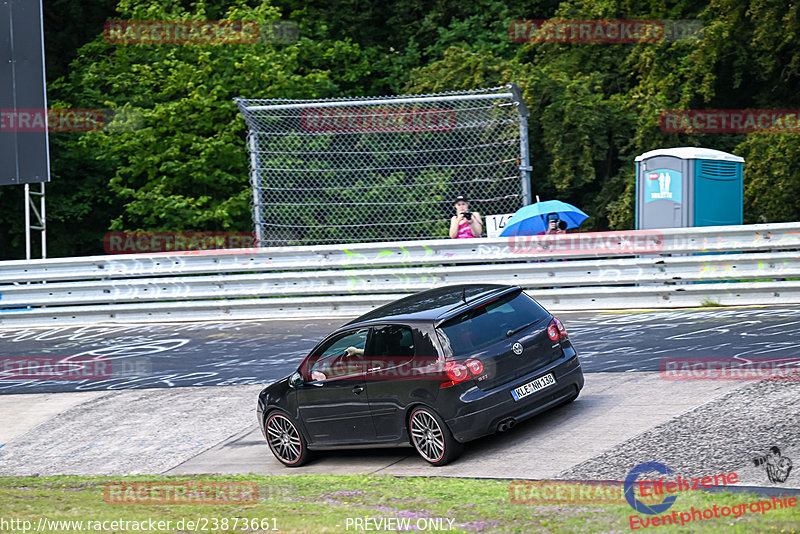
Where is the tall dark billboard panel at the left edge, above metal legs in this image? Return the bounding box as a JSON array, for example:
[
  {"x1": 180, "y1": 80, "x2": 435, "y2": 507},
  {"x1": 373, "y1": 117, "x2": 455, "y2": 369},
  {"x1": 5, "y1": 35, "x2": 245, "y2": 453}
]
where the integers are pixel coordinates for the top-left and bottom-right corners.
[{"x1": 0, "y1": 0, "x2": 50, "y2": 185}]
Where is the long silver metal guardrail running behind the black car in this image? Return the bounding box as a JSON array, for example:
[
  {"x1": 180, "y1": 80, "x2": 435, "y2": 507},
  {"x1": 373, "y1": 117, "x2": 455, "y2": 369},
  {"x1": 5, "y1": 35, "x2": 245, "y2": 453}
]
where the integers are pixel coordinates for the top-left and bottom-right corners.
[{"x1": 0, "y1": 223, "x2": 800, "y2": 326}]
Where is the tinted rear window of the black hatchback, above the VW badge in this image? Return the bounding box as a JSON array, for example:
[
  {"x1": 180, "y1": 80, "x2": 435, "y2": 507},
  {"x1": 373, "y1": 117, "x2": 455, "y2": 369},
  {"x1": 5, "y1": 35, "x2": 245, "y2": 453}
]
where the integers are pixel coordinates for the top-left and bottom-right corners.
[{"x1": 437, "y1": 291, "x2": 550, "y2": 356}]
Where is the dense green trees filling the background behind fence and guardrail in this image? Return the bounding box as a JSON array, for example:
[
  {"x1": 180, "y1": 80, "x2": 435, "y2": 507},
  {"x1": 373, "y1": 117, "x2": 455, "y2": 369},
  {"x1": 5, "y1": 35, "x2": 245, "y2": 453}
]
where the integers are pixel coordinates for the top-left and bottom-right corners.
[{"x1": 0, "y1": 0, "x2": 800, "y2": 258}]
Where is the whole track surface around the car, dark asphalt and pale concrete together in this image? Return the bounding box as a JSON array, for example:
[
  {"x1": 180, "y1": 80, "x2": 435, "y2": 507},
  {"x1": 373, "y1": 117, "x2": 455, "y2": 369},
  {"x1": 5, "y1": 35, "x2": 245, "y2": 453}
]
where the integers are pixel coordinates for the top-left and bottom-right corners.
[{"x1": 0, "y1": 306, "x2": 800, "y2": 492}]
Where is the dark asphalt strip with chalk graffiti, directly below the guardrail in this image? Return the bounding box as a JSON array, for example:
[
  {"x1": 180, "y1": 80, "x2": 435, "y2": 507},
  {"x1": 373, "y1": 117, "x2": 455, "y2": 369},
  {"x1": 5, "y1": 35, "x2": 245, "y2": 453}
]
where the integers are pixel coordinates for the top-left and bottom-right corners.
[{"x1": 0, "y1": 306, "x2": 800, "y2": 395}]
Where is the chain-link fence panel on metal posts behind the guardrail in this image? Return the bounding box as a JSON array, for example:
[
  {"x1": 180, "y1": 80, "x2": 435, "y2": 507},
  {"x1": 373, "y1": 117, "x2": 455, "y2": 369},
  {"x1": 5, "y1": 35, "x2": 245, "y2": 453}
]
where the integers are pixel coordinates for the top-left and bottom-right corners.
[{"x1": 236, "y1": 84, "x2": 530, "y2": 246}]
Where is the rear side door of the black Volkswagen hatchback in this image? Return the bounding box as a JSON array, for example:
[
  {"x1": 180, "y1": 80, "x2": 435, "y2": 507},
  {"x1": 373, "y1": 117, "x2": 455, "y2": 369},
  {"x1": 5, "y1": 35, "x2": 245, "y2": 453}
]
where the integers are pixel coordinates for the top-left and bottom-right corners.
[{"x1": 365, "y1": 325, "x2": 441, "y2": 441}]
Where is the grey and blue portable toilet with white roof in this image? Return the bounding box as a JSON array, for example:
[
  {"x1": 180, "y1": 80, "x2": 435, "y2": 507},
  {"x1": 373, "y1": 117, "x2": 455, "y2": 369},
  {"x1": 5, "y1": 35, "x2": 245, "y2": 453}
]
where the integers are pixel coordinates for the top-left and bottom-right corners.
[{"x1": 636, "y1": 147, "x2": 744, "y2": 230}]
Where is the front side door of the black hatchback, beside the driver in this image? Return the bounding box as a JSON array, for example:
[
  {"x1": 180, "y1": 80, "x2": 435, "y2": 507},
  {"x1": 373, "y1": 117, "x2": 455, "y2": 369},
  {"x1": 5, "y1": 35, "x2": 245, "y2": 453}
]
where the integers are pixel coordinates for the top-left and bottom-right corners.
[{"x1": 297, "y1": 328, "x2": 375, "y2": 445}]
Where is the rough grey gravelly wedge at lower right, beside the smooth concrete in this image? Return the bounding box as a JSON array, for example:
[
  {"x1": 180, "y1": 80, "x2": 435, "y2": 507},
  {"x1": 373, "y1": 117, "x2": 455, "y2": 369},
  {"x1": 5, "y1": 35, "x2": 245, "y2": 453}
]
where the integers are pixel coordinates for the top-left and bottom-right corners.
[{"x1": 558, "y1": 381, "x2": 800, "y2": 488}]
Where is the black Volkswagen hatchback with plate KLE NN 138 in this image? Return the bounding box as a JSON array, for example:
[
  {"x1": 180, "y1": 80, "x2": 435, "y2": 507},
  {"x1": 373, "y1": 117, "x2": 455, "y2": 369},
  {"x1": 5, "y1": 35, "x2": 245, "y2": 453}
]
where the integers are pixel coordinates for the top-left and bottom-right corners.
[{"x1": 258, "y1": 284, "x2": 583, "y2": 467}]
